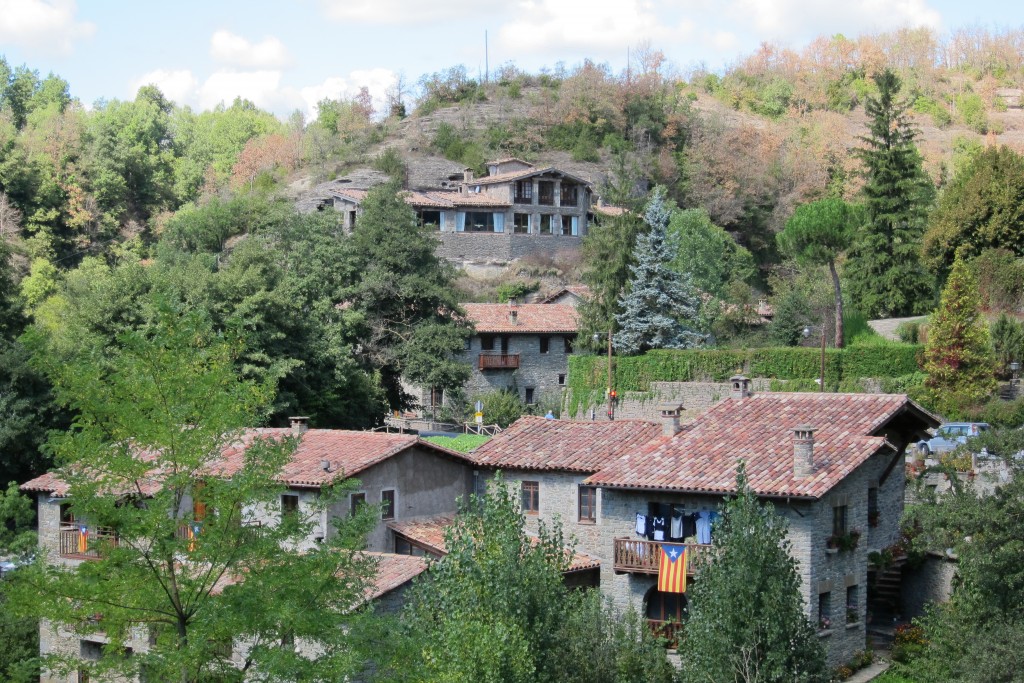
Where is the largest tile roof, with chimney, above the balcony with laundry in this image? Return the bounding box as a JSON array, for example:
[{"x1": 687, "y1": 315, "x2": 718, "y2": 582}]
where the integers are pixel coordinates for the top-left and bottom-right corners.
[{"x1": 586, "y1": 393, "x2": 938, "y2": 499}]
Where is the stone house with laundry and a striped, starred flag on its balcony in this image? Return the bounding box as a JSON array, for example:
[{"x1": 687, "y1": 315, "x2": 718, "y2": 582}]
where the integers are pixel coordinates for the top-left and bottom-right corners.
[{"x1": 468, "y1": 378, "x2": 938, "y2": 667}]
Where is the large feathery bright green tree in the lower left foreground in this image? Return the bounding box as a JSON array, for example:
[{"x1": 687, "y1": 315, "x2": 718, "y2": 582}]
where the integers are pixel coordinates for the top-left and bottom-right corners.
[{"x1": 9, "y1": 302, "x2": 373, "y2": 683}]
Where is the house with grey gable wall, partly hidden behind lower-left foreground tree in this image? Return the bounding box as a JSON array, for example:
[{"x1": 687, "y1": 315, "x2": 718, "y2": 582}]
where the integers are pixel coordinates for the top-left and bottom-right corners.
[{"x1": 20, "y1": 418, "x2": 476, "y2": 683}]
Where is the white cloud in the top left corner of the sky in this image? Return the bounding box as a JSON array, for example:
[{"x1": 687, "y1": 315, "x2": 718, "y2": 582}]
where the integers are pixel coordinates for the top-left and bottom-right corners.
[{"x1": 0, "y1": 0, "x2": 96, "y2": 54}]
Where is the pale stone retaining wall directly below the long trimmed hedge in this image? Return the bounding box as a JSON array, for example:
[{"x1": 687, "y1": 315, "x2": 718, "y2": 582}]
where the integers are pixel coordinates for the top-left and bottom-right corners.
[{"x1": 571, "y1": 378, "x2": 771, "y2": 421}]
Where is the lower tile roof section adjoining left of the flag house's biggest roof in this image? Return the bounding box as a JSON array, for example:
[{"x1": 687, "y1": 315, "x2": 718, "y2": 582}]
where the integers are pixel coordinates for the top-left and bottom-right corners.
[{"x1": 473, "y1": 416, "x2": 662, "y2": 472}]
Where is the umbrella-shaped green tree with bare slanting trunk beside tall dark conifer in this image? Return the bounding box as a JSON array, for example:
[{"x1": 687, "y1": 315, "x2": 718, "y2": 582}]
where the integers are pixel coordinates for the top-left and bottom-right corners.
[{"x1": 777, "y1": 198, "x2": 860, "y2": 348}]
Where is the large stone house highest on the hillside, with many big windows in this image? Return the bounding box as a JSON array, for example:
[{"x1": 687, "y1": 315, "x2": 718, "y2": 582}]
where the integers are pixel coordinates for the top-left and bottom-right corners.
[{"x1": 330, "y1": 159, "x2": 594, "y2": 263}]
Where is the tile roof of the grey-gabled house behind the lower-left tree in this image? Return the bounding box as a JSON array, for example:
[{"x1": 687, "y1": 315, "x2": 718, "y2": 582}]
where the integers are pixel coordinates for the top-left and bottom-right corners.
[{"x1": 20, "y1": 428, "x2": 474, "y2": 496}]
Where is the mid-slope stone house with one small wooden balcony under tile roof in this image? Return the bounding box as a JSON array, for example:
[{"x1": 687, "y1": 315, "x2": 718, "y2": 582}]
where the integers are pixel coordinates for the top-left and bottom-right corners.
[{"x1": 461, "y1": 302, "x2": 579, "y2": 409}]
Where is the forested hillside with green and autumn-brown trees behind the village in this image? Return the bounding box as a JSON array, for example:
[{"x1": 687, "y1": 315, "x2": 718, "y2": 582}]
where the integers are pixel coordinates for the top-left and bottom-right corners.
[{"x1": 0, "y1": 29, "x2": 1024, "y2": 485}]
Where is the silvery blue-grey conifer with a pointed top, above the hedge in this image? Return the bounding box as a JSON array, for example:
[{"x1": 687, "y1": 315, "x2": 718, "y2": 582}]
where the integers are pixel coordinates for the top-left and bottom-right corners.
[{"x1": 614, "y1": 187, "x2": 705, "y2": 353}]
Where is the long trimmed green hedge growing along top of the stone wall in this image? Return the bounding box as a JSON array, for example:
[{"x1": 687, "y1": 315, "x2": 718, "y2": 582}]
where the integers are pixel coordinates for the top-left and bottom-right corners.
[{"x1": 568, "y1": 344, "x2": 924, "y2": 415}]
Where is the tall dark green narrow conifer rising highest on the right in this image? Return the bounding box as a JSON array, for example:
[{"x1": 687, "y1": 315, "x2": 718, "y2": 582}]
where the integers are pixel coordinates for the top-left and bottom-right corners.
[{"x1": 845, "y1": 70, "x2": 935, "y2": 316}]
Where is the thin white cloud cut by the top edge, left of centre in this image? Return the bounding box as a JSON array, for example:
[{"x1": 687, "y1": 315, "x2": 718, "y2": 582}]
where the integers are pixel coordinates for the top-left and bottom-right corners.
[{"x1": 321, "y1": 0, "x2": 499, "y2": 23}]
